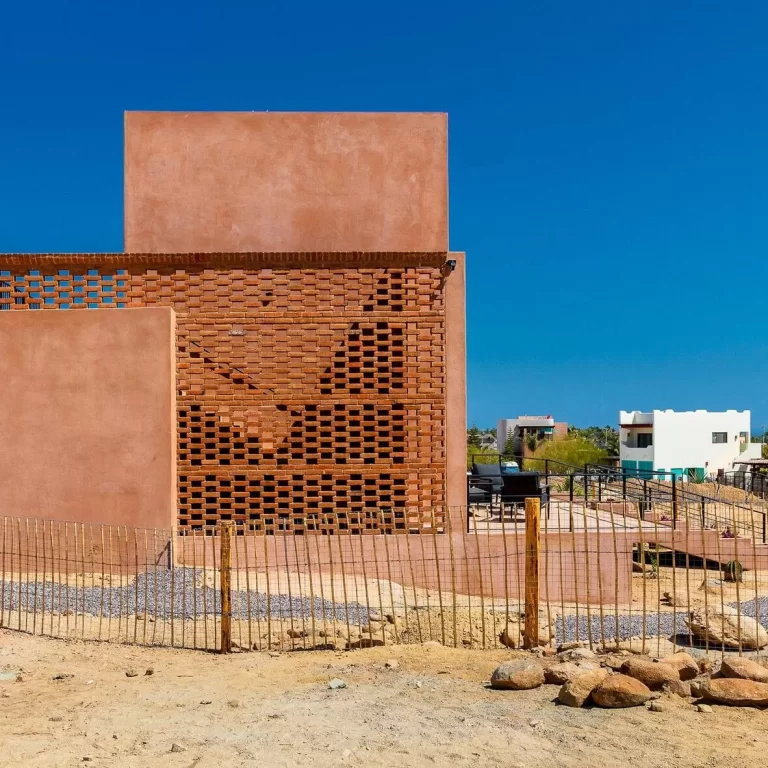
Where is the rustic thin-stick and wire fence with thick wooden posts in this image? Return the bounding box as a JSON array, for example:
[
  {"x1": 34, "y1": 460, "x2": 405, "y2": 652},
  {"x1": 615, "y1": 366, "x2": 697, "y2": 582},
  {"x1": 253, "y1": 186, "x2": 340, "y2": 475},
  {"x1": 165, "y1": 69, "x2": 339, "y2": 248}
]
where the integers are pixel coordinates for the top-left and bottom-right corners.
[{"x1": 0, "y1": 498, "x2": 768, "y2": 655}]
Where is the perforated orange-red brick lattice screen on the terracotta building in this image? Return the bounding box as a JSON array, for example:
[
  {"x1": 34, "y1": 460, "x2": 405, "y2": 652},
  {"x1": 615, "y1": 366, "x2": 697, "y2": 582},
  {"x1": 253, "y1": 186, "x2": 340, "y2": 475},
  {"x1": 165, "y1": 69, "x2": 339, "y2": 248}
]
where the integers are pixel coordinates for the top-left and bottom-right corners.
[{"x1": 0, "y1": 254, "x2": 446, "y2": 533}]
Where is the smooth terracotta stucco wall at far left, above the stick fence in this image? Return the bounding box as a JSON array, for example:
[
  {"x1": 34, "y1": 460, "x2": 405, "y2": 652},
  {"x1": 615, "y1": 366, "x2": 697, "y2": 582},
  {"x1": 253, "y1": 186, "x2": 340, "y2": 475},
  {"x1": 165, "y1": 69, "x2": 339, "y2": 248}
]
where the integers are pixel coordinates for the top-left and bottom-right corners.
[{"x1": 0, "y1": 308, "x2": 176, "y2": 529}]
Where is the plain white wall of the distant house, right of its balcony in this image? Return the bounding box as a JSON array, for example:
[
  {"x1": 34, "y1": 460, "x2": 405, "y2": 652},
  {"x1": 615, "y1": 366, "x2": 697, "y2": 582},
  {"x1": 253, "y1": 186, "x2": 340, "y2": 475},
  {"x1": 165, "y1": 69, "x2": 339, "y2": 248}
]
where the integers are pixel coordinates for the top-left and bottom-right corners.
[{"x1": 652, "y1": 411, "x2": 750, "y2": 474}]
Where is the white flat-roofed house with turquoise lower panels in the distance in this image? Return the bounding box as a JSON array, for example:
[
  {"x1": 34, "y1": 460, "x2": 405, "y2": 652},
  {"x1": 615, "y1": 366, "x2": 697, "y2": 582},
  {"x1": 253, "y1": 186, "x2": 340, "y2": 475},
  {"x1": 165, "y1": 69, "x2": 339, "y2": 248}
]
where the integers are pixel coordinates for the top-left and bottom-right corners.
[{"x1": 619, "y1": 411, "x2": 762, "y2": 479}]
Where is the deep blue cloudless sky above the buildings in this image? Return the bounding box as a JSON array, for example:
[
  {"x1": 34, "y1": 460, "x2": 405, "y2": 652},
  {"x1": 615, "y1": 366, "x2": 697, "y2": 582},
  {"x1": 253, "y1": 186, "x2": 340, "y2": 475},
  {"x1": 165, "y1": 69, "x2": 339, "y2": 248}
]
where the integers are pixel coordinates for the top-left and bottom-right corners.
[{"x1": 0, "y1": 0, "x2": 768, "y2": 429}]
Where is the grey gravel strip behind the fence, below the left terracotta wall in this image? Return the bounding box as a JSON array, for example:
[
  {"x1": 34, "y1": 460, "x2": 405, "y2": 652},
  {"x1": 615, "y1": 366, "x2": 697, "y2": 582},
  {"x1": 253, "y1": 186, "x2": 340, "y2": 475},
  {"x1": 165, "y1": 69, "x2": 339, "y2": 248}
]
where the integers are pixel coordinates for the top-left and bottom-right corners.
[{"x1": 0, "y1": 568, "x2": 369, "y2": 624}]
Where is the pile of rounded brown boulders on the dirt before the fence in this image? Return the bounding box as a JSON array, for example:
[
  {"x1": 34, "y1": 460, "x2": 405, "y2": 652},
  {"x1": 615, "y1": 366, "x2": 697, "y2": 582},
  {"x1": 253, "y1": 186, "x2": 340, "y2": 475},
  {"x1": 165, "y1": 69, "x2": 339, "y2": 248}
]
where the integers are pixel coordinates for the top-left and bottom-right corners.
[{"x1": 491, "y1": 643, "x2": 768, "y2": 711}]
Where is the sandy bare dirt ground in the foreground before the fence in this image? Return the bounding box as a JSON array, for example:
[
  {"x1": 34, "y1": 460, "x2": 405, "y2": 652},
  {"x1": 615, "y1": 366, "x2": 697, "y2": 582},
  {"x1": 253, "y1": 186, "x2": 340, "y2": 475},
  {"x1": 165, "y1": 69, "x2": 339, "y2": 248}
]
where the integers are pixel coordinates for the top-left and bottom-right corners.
[{"x1": 0, "y1": 631, "x2": 768, "y2": 768}]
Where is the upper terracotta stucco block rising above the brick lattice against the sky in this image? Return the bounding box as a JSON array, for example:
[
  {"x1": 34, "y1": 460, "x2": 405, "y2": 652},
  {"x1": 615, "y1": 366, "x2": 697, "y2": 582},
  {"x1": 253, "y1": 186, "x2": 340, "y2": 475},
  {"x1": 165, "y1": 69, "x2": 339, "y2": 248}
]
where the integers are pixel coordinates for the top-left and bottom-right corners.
[{"x1": 125, "y1": 112, "x2": 448, "y2": 253}]
